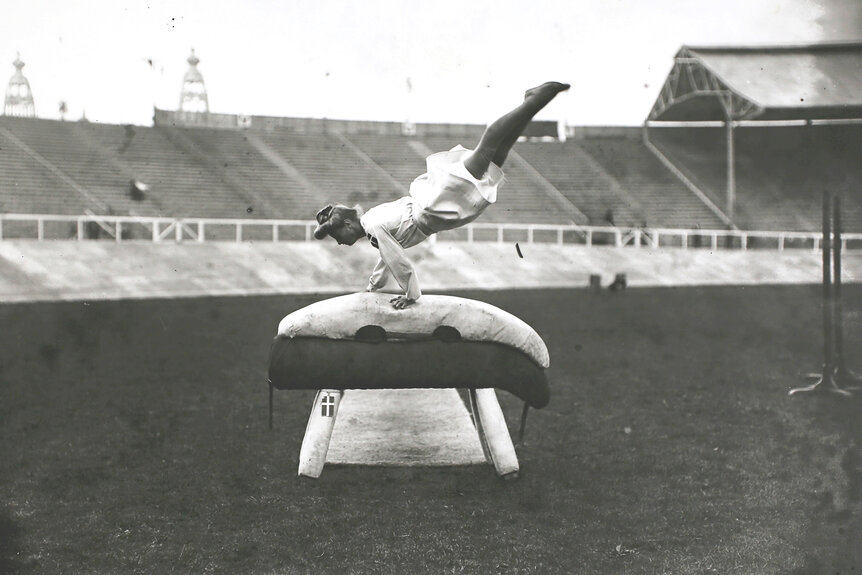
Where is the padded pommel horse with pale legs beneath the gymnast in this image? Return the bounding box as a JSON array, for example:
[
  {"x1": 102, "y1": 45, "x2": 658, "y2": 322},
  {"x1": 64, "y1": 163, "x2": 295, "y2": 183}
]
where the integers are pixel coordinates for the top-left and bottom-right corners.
[{"x1": 269, "y1": 292, "x2": 550, "y2": 478}]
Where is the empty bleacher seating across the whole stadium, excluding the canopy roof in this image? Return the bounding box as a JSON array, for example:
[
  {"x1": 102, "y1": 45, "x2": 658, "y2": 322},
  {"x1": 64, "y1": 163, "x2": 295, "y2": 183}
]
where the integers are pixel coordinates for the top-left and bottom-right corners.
[{"x1": 0, "y1": 116, "x2": 862, "y2": 231}]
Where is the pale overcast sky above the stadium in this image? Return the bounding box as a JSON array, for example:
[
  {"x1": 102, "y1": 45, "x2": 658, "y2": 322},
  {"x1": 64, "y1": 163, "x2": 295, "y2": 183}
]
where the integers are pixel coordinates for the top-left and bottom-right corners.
[{"x1": 0, "y1": 0, "x2": 862, "y2": 125}]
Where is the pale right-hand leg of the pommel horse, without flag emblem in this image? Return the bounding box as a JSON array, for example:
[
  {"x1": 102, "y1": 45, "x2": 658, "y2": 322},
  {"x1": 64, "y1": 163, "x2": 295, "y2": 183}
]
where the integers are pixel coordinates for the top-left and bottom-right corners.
[{"x1": 469, "y1": 388, "x2": 519, "y2": 479}]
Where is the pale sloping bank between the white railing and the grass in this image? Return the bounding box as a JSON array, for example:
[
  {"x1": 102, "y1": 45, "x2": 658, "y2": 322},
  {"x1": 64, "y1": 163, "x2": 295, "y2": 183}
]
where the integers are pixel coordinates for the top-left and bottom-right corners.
[{"x1": 0, "y1": 240, "x2": 862, "y2": 302}]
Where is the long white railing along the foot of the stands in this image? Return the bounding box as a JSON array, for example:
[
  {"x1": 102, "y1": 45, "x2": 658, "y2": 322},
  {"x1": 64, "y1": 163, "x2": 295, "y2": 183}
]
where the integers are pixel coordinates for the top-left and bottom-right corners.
[{"x1": 0, "y1": 214, "x2": 862, "y2": 251}]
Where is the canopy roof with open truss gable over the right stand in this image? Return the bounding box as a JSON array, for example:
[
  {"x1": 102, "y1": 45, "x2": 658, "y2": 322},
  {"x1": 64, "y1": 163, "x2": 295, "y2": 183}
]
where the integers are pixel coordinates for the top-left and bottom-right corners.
[{"x1": 649, "y1": 43, "x2": 862, "y2": 121}]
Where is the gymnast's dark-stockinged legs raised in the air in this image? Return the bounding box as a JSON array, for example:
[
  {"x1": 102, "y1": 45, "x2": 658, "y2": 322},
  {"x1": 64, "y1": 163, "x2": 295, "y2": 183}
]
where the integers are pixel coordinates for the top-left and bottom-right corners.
[{"x1": 464, "y1": 82, "x2": 569, "y2": 180}]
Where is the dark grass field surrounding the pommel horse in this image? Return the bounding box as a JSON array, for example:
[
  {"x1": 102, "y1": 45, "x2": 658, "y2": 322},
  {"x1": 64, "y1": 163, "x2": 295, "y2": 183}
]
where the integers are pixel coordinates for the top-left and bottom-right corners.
[{"x1": 0, "y1": 285, "x2": 862, "y2": 574}]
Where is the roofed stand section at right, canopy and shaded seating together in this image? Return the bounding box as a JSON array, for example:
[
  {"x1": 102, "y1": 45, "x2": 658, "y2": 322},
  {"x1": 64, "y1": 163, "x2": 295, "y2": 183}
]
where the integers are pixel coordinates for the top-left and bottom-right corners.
[{"x1": 647, "y1": 43, "x2": 862, "y2": 231}]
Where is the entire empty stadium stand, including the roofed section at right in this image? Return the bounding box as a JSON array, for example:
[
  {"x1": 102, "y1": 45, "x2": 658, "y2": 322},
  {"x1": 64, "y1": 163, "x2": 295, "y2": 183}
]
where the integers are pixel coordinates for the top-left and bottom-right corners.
[{"x1": 6, "y1": 44, "x2": 862, "y2": 231}]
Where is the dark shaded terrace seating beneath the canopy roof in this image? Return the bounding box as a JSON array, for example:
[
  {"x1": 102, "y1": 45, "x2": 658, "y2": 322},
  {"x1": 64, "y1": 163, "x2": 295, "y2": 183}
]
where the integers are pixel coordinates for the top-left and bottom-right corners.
[{"x1": 649, "y1": 125, "x2": 862, "y2": 232}]
